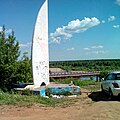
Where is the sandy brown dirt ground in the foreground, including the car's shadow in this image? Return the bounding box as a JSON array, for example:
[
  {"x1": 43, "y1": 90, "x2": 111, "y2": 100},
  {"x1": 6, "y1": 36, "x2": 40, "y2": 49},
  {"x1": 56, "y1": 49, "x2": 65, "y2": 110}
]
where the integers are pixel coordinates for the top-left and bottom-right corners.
[{"x1": 0, "y1": 90, "x2": 120, "y2": 120}]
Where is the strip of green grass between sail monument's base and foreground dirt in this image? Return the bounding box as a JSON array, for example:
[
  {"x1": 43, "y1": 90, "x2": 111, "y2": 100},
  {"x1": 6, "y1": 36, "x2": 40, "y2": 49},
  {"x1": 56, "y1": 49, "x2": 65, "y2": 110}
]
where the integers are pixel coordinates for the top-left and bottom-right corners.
[{"x1": 0, "y1": 92, "x2": 75, "y2": 107}]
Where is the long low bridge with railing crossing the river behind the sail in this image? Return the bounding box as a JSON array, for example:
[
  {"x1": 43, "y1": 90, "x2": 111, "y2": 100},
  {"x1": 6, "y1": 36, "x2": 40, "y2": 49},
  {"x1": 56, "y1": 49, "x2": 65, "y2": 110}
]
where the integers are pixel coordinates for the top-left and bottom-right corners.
[{"x1": 50, "y1": 71, "x2": 100, "y2": 80}]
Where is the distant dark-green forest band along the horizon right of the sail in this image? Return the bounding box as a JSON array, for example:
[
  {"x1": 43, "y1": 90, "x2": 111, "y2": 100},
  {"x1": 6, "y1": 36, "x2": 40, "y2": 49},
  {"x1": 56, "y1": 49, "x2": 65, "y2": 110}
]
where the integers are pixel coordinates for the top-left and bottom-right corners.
[{"x1": 50, "y1": 59, "x2": 120, "y2": 71}]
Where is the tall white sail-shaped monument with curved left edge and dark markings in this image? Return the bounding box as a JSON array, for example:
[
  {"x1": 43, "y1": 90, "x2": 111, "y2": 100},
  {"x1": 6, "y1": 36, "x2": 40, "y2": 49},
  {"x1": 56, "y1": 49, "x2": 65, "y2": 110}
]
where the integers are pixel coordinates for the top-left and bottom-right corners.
[{"x1": 32, "y1": 0, "x2": 49, "y2": 86}]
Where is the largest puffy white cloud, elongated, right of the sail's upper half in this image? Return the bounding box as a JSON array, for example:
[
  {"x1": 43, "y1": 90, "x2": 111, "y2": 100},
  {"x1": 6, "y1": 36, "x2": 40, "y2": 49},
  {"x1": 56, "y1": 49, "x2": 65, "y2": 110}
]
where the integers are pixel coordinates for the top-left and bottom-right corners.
[{"x1": 50, "y1": 17, "x2": 100, "y2": 43}]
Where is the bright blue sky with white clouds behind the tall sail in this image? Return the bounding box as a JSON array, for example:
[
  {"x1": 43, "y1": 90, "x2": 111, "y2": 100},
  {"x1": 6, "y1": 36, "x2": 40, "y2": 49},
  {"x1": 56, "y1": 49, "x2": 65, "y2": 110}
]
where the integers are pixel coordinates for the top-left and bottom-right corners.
[{"x1": 0, "y1": 0, "x2": 120, "y2": 61}]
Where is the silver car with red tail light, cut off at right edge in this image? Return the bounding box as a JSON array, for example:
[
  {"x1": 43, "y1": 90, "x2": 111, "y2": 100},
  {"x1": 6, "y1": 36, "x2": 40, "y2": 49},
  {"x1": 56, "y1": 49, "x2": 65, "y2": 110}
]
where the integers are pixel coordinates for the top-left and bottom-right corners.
[{"x1": 101, "y1": 71, "x2": 120, "y2": 98}]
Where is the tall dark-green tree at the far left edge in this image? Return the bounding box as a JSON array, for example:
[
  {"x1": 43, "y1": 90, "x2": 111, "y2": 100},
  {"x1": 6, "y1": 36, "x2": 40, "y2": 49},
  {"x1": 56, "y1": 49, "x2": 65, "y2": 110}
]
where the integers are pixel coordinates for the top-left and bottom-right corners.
[{"x1": 0, "y1": 26, "x2": 20, "y2": 90}]
